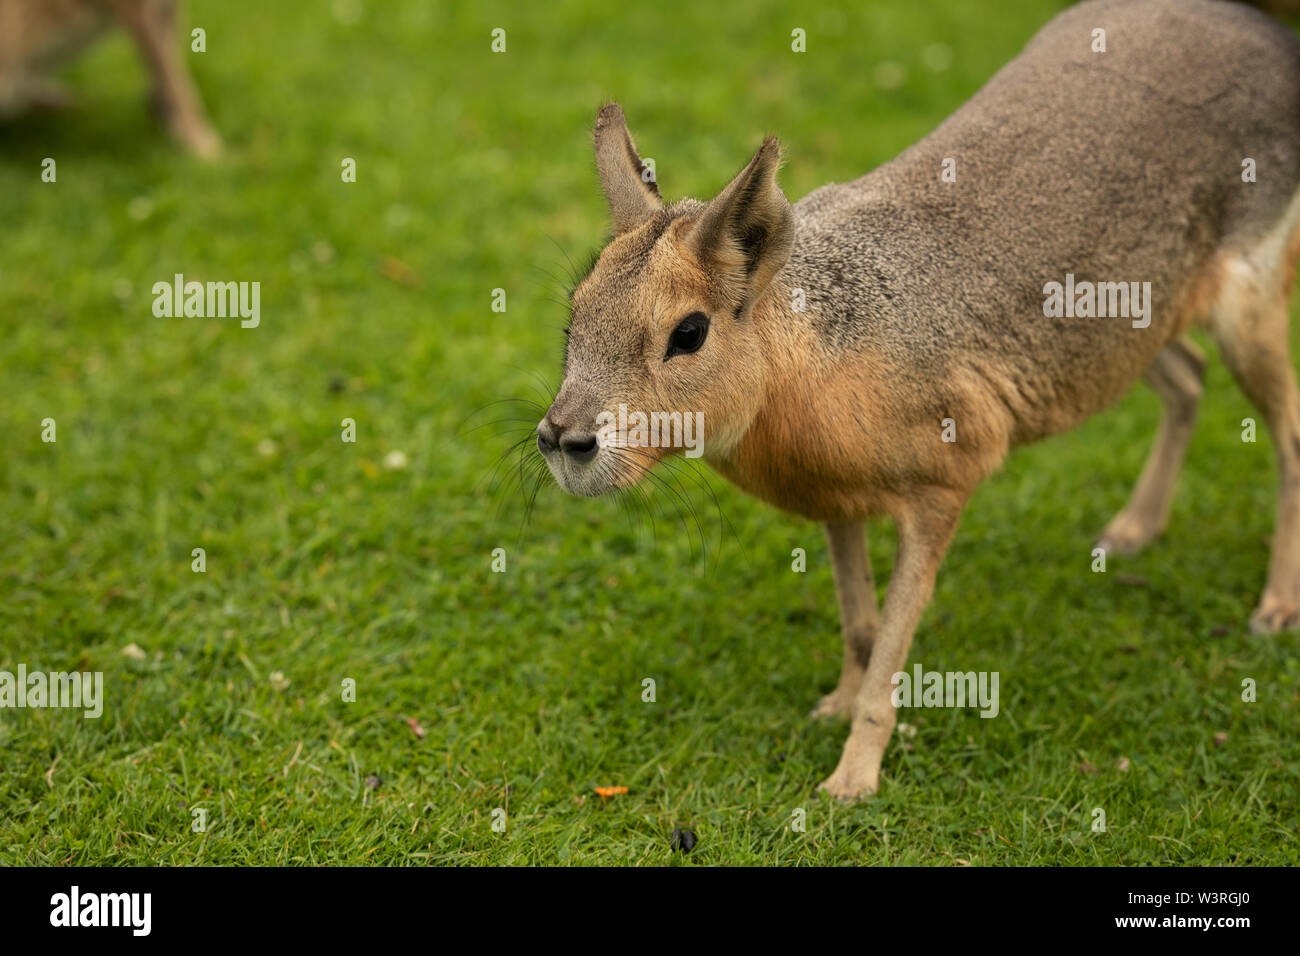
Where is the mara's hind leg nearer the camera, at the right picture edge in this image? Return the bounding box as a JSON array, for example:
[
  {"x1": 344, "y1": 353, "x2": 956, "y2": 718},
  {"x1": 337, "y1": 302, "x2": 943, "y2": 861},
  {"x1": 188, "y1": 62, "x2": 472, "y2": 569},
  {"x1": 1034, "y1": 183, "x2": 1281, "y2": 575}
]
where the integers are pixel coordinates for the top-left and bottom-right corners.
[{"x1": 1209, "y1": 255, "x2": 1300, "y2": 633}]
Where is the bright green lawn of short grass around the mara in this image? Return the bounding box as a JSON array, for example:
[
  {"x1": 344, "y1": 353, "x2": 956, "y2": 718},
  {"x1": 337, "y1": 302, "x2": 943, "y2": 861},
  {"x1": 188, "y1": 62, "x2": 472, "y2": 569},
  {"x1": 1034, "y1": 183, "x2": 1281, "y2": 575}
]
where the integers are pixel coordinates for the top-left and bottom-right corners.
[{"x1": 0, "y1": 0, "x2": 1300, "y2": 865}]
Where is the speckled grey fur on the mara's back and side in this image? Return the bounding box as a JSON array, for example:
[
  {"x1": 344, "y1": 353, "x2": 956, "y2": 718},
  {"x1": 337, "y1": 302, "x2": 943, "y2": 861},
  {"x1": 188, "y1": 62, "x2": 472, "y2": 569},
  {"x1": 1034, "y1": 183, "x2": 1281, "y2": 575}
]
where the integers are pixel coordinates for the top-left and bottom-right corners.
[{"x1": 783, "y1": 0, "x2": 1300, "y2": 438}]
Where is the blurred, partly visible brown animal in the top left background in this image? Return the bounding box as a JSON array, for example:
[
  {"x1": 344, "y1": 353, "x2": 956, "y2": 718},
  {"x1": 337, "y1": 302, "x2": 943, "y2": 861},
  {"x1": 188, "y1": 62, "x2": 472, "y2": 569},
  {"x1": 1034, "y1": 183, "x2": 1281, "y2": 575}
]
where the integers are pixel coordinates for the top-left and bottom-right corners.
[{"x1": 0, "y1": 0, "x2": 221, "y2": 157}]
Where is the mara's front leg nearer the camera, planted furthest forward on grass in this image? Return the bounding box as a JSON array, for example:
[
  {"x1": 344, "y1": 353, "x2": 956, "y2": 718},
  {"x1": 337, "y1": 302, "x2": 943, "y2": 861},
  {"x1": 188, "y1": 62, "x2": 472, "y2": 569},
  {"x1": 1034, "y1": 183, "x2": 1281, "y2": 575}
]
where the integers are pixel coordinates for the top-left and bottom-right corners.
[{"x1": 822, "y1": 489, "x2": 969, "y2": 800}]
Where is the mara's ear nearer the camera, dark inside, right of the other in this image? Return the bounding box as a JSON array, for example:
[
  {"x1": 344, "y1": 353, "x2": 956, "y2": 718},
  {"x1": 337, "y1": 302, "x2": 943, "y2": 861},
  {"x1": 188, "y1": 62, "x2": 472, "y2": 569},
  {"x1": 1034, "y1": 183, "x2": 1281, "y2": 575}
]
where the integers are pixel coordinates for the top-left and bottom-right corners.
[{"x1": 689, "y1": 137, "x2": 794, "y2": 307}]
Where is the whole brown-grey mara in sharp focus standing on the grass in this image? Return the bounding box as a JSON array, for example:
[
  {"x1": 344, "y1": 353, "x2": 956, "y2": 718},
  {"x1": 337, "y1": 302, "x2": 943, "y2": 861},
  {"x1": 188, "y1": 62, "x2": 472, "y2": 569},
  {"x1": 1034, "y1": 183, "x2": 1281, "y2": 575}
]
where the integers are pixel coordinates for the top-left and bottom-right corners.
[{"x1": 537, "y1": 0, "x2": 1300, "y2": 799}]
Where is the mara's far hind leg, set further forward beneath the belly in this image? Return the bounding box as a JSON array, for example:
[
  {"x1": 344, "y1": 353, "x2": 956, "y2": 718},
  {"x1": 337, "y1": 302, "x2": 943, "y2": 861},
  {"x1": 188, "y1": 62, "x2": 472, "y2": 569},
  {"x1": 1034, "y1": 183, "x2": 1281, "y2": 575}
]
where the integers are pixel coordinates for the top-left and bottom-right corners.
[{"x1": 1097, "y1": 339, "x2": 1205, "y2": 554}]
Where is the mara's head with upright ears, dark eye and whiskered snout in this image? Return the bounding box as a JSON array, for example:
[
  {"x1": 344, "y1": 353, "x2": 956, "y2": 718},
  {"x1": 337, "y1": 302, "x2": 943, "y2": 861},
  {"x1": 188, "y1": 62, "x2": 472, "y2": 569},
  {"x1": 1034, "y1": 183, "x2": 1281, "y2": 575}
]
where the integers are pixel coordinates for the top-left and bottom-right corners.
[{"x1": 537, "y1": 104, "x2": 794, "y2": 497}]
